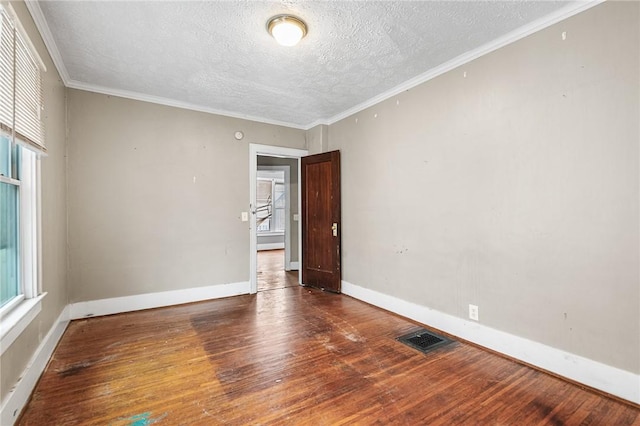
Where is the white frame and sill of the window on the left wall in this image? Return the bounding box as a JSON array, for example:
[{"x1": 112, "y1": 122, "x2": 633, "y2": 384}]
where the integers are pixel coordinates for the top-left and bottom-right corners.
[{"x1": 0, "y1": 4, "x2": 46, "y2": 355}]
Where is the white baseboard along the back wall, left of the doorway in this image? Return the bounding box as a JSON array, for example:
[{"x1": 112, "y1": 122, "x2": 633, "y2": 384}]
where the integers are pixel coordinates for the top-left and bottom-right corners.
[{"x1": 69, "y1": 281, "x2": 250, "y2": 319}]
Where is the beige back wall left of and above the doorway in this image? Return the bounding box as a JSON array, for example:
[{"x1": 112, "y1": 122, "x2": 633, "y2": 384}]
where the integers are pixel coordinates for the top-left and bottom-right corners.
[{"x1": 68, "y1": 90, "x2": 304, "y2": 302}]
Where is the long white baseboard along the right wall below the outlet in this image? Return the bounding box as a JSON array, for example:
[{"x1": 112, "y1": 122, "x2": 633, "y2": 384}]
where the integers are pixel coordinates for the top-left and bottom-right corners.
[{"x1": 342, "y1": 281, "x2": 640, "y2": 404}]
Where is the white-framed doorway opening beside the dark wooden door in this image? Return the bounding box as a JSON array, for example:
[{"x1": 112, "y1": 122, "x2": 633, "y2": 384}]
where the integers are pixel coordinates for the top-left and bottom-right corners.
[{"x1": 249, "y1": 144, "x2": 307, "y2": 293}]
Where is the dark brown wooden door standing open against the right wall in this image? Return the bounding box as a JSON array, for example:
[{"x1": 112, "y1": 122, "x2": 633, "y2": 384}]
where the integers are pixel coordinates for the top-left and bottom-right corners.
[{"x1": 301, "y1": 151, "x2": 342, "y2": 293}]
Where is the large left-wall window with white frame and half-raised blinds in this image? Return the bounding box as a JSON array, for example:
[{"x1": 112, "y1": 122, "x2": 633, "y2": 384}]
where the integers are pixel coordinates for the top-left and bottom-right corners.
[{"x1": 0, "y1": 5, "x2": 46, "y2": 352}]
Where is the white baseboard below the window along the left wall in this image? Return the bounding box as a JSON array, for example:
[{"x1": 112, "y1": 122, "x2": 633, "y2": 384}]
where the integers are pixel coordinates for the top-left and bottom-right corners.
[{"x1": 0, "y1": 305, "x2": 69, "y2": 426}]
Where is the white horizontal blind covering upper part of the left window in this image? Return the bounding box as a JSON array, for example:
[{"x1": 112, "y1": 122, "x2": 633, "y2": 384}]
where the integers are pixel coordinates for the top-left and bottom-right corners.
[{"x1": 0, "y1": 9, "x2": 46, "y2": 151}]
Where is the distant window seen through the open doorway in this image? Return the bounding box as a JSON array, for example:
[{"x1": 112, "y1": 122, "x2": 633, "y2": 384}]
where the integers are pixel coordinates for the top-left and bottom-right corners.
[{"x1": 256, "y1": 176, "x2": 286, "y2": 233}]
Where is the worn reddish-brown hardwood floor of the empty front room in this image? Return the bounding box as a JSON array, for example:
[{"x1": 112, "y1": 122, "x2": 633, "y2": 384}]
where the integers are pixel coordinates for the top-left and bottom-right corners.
[{"x1": 19, "y1": 286, "x2": 640, "y2": 426}]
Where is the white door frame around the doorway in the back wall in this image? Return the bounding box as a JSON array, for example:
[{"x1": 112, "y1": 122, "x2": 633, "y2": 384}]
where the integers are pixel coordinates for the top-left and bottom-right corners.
[{"x1": 249, "y1": 143, "x2": 309, "y2": 294}]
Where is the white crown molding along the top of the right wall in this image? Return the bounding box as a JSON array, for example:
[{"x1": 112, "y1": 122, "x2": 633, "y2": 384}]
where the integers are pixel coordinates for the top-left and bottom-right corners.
[{"x1": 324, "y1": 0, "x2": 605, "y2": 126}]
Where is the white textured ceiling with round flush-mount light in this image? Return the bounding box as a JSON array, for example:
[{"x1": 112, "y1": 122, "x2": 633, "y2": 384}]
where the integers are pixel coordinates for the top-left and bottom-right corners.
[{"x1": 30, "y1": 0, "x2": 577, "y2": 128}]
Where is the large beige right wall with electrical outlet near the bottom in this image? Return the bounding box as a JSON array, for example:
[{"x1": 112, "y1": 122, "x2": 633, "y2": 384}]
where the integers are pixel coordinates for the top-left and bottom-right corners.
[{"x1": 329, "y1": 2, "x2": 640, "y2": 373}]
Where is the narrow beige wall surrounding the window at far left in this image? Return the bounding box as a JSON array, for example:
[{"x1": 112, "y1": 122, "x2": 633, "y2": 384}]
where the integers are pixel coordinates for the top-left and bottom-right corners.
[{"x1": 0, "y1": 2, "x2": 68, "y2": 400}]
